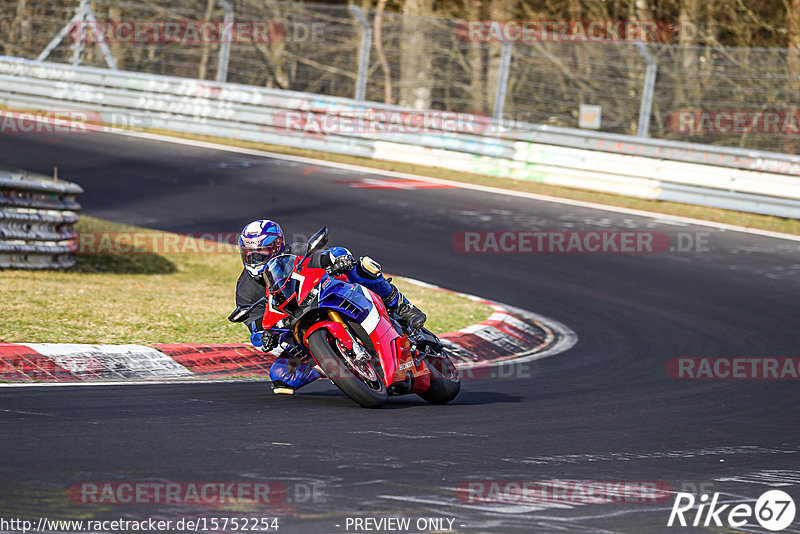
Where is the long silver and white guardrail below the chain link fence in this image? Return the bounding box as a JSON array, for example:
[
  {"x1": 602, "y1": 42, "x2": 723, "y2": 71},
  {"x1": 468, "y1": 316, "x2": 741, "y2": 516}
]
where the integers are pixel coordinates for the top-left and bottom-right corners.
[{"x1": 0, "y1": 57, "x2": 800, "y2": 218}]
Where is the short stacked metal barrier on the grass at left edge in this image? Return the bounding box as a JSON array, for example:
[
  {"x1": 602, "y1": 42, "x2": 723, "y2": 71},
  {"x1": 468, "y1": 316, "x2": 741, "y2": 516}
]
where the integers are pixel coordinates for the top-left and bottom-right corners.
[{"x1": 0, "y1": 168, "x2": 83, "y2": 269}]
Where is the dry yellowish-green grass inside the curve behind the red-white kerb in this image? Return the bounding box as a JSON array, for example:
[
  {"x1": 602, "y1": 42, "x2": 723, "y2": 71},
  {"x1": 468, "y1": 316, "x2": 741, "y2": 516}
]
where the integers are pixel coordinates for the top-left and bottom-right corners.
[{"x1": 0, "y1": 217, "x2": 491, "y2": 344}]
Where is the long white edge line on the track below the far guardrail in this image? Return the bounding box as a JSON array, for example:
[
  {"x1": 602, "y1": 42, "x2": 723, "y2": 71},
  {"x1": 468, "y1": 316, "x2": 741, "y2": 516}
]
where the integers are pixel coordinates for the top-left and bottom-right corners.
[{"x1": 105, "y1": 126, "x2": 800, "y2": 241}]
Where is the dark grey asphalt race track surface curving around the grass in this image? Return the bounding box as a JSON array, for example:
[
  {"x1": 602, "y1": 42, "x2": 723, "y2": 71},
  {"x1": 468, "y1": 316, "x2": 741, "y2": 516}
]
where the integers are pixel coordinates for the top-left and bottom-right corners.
[{"x1": 0, "y1": 134, "x2": 800, "y2": 533}]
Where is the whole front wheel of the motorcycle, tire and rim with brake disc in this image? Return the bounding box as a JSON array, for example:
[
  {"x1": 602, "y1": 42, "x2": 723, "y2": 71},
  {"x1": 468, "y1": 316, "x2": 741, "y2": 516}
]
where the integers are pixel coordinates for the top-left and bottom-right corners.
[{"x1": 308, "y1": 329, "x2": 388, "y2": 408}]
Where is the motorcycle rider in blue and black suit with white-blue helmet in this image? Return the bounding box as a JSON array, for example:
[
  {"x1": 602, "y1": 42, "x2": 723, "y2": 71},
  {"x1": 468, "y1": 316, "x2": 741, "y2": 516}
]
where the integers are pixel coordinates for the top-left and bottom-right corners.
[{"x1": 236, "y1": 219, "x2": 427, "y2": 395}]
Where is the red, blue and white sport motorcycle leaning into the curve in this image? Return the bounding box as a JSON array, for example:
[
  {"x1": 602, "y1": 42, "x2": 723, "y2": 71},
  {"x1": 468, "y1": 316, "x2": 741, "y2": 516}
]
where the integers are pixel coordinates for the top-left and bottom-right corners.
[{"x1": 228, "y1": 227, "x2": 461, "y2": 408}]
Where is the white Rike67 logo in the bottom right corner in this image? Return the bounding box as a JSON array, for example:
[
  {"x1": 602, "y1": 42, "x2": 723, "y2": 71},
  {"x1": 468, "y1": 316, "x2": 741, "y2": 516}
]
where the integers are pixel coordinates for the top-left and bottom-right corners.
[{"x1": 667, "y1": 490, "x2": 796, "y2": 532}]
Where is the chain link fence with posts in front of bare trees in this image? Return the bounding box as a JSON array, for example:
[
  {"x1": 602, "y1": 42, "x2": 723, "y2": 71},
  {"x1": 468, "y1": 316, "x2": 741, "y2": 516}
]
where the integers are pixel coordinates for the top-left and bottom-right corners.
[{"x1": 0, "y1": 0, "x2": 800, "y2": 153}]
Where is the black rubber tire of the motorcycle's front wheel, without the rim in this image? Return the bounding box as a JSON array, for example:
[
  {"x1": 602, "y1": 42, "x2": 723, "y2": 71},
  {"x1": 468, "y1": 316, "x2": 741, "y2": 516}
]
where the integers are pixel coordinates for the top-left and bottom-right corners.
[{"x1": 308, "y1": 329, "x2": 388, "y2": 408}]
